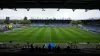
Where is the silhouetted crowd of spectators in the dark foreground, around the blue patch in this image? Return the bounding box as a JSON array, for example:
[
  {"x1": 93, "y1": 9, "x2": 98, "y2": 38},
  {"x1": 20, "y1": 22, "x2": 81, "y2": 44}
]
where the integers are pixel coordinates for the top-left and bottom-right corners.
[{"x1": 20, "y1": 44, "x2": 80, "y2": 53}]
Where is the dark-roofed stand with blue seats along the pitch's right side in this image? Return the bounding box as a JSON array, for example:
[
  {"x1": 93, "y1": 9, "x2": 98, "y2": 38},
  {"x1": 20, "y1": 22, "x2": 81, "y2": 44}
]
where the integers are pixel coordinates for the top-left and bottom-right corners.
[{"x1": 80, "y1": 20, "x2": 100, "y2": 32}]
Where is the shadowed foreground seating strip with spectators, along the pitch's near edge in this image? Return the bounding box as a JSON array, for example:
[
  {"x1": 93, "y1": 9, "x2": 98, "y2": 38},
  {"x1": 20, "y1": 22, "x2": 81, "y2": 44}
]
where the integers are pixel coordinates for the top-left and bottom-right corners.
[{"x1": 0, "y1": 41, "x2": 100, "y2": 53}]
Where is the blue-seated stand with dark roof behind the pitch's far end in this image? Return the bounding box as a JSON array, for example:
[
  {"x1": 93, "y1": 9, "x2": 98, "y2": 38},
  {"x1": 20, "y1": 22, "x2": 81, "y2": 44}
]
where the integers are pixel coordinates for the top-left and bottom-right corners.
[{"x1": 30, "y1": 19, "x2": 71, "y2": 26}]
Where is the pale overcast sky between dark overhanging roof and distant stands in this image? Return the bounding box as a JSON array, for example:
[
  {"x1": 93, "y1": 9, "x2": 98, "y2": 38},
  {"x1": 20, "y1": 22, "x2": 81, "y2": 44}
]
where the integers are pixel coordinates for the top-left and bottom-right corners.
[{"x1": 0, "y1": 9, "x2": 100, "y2": 20}]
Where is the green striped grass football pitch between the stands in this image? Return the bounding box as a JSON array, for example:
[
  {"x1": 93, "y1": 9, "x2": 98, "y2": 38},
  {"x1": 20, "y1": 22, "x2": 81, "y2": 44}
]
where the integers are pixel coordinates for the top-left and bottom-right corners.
[{"x1": 0, "y1": 27, "x2": 100, "y2": 43}]
